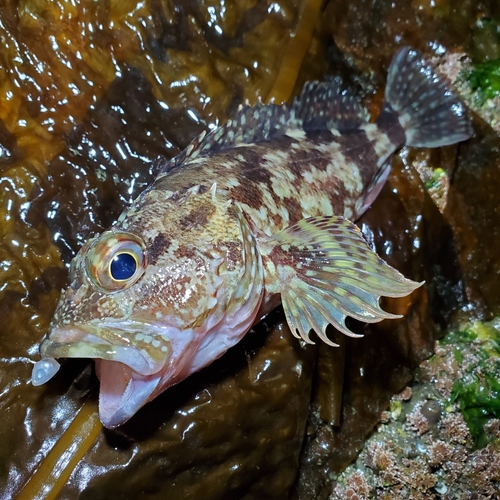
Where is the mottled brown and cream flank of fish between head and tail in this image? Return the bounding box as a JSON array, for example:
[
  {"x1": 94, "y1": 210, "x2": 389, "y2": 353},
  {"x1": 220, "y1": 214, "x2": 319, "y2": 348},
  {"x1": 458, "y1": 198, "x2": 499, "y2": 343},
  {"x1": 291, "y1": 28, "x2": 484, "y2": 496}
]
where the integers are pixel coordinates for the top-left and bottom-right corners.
[{"x1": 145, "y1": 124, "x2": 401, "y2": 235}]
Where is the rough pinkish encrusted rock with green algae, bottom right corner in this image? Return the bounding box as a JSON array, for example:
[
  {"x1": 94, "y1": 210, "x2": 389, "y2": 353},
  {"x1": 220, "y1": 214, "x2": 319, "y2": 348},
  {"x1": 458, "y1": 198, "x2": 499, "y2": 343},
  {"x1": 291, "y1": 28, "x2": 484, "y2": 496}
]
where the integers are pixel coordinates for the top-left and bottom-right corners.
[{"x1": 330, "y1": 318, "x2": 500, "y2": 500}]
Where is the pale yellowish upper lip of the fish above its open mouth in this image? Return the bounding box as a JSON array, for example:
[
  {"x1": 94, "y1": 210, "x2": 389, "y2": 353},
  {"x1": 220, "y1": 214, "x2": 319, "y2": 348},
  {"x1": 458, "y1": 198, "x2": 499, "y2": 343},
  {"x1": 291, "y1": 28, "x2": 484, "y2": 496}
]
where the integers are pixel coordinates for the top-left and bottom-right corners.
[{"x1": 40, "y1": 327, "x2": 171, "y2": 376}]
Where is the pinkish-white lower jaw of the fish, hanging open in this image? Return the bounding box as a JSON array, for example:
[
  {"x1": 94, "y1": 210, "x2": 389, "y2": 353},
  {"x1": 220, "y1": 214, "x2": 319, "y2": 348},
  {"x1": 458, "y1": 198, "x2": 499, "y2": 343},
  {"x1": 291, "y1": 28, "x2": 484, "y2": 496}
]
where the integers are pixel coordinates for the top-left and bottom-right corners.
[{"x1": 96, "y1": 360, "x2": 161, "y2": 429}]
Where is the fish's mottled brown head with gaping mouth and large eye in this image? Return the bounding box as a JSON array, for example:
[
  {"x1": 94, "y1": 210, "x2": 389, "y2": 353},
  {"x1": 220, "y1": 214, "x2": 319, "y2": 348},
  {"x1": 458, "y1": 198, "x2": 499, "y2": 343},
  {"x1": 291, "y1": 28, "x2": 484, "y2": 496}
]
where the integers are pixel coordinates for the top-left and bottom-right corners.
[{"x1": 32, "y1": 186, "x2": 263, "y2": 428}]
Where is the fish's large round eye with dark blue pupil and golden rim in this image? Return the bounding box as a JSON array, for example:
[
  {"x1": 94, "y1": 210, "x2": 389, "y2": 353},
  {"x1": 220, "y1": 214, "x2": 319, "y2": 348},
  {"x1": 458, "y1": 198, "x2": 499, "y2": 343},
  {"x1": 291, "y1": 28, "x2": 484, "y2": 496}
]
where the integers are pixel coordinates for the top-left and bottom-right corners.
[{"x1": 86, "y1": 232, "x2": 146, "y2": 292}]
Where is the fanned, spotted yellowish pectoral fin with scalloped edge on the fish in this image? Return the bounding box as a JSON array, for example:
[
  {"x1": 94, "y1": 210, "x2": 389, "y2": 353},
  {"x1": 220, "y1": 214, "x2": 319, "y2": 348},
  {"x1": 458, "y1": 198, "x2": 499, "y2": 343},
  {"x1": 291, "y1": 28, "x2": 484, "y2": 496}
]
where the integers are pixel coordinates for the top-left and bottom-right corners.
[{"x1": 262, "y1": 217, "x2": 422, "y2": 345}]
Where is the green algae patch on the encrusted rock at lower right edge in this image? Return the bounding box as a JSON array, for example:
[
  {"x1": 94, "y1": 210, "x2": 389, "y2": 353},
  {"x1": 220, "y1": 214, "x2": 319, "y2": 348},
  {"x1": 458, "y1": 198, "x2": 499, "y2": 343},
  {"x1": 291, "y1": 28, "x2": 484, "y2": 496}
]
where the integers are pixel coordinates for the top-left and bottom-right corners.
[{"x1": 441, "y1": 320, "x2": 500, "y2": 448}]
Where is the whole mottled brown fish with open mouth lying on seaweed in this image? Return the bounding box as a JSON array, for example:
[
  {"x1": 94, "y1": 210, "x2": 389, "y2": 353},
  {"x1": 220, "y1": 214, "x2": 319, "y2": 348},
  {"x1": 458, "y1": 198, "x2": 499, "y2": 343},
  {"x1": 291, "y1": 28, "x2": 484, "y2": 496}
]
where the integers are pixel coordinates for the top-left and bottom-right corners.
[{"x1": 31, "y1": 47, "x2": 472, "y2": 428}]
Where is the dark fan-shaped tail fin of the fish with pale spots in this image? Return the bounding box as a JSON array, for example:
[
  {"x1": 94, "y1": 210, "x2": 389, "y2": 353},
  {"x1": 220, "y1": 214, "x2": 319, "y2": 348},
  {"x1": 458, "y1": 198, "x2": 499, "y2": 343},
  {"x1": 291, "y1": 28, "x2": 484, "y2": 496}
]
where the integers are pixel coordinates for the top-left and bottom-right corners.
[{"x1": 385, "y1": 47, "x2": 472, "y2": 148}]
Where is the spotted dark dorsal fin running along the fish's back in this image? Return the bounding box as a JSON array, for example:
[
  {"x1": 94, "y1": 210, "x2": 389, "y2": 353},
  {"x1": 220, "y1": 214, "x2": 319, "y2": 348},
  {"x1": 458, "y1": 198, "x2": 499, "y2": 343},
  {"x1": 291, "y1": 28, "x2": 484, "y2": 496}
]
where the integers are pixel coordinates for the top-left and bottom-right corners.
[{"x1": 162, "y1": 81, "x2": 366, "y2": 173}]
